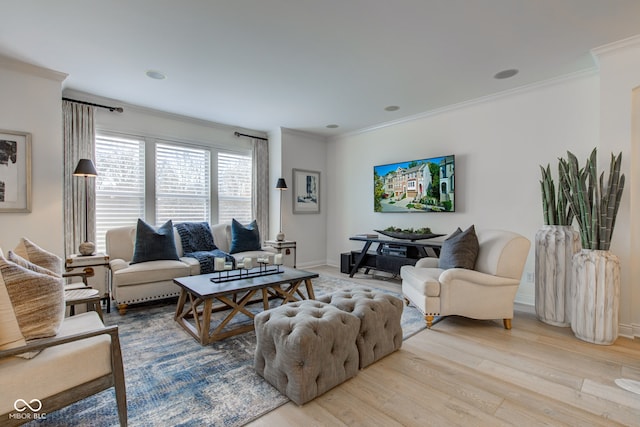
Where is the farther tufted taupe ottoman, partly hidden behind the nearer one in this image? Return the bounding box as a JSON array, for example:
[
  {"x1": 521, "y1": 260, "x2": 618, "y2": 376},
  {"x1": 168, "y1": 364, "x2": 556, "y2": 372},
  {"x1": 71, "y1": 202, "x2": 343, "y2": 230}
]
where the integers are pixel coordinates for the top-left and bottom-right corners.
[{"x1": 318, "y1": 287, "x2": 403, "y2": 369}]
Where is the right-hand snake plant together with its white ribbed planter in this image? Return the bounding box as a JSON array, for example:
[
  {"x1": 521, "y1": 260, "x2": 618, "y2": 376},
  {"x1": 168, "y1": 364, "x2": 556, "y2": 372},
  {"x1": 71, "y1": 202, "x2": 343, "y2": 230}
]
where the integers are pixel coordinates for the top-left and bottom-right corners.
[{"x1": 560, "y1": 148, "x2": 624, "y2": 344}]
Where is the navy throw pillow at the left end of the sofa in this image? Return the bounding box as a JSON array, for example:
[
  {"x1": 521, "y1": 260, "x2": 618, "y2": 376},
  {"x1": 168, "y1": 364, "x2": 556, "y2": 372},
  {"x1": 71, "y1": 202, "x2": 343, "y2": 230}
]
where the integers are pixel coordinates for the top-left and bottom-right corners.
[{"x1": 131, "y1": 219, "x2": 179, "y2": 264}]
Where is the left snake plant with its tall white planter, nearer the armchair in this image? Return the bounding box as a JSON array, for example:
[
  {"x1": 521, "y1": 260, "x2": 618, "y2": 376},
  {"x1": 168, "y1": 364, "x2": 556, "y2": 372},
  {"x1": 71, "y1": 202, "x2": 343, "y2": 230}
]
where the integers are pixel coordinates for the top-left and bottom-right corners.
[{"x1": 535, "y1": 165, "x2": 580, "y2": 327}]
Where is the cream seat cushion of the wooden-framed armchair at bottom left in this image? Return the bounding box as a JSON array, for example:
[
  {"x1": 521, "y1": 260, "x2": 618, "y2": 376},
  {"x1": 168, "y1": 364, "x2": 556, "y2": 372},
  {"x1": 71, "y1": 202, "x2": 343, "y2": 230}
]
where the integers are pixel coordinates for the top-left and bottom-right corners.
[{"x1": 0, "y1": 311, "x2": 111, "y2": 416}]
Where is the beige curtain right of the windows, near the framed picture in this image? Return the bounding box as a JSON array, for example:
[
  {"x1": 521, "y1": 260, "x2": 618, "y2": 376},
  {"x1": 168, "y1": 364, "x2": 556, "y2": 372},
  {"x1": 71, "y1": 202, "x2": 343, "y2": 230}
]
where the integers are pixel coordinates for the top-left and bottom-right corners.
[{"x1": 251, "y1": 138, "x2": 270, "y2": 240}]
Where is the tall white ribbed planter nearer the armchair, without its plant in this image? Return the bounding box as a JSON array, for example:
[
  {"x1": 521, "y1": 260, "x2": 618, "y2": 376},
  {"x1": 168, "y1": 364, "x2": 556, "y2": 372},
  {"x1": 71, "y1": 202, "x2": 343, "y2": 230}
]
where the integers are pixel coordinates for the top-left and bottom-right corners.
[{"x1": 535, "y1": 225, "x2": 581, "y2": 327}]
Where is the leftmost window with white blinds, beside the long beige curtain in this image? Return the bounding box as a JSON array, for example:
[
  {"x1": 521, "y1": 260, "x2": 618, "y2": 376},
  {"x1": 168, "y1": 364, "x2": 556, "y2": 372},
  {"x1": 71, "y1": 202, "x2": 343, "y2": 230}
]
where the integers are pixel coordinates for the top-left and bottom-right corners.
[{"x1": 96, "y1": 135, "x2": 145, "y2": 251}]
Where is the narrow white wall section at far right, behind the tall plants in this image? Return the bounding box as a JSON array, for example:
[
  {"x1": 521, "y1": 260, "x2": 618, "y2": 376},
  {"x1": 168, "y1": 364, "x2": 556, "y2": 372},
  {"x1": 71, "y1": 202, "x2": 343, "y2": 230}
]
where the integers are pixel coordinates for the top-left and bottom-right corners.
[{"x1": 595, "y1": 36, "x2": 640, "y2": 336}]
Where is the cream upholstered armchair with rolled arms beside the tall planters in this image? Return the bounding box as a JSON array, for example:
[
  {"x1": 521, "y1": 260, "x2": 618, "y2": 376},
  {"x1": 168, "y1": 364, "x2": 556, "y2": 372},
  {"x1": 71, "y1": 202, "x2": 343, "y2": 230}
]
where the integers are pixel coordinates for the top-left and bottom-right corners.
[{"x1": 400, "y1": 230, "x2": 530, "y2": 329}]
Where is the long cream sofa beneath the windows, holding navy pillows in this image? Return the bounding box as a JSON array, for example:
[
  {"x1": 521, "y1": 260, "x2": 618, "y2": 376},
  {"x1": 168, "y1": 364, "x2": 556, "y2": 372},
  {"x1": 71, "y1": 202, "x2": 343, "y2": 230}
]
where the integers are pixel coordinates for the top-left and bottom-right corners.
[{"x1": 106, "y1": 224, "x2": 275, "y2": 314}]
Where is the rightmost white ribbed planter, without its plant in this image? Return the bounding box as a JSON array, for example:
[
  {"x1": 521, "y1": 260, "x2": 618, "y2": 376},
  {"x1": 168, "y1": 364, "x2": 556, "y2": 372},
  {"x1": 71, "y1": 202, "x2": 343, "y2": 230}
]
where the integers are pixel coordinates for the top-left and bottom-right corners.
[{"x1": 571, "y1": 249, "x2": 620, "y2": 345}]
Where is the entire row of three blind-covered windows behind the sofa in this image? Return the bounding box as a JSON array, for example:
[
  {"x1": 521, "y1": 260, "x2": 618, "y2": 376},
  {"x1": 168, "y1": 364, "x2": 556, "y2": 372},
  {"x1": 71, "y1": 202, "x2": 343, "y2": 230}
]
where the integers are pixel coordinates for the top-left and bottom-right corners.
[{"x1": 96, "y1": 134, "x2": 253, "y2": 251}]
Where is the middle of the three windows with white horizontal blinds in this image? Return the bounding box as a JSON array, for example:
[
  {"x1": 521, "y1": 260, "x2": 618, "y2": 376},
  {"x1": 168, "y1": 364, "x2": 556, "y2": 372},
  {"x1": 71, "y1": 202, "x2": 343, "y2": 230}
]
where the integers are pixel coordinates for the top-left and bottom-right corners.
[{"x1": 155, "y1": 143, "x2": 210, "y2": 224}]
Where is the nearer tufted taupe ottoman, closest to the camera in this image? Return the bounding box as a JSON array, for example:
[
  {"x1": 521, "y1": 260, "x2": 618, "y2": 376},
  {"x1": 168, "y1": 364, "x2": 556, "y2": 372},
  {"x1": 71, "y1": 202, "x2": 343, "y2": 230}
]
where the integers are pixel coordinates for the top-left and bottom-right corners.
[{"x1": 254, "y1": 300, "x2": 360, "y2": 405}]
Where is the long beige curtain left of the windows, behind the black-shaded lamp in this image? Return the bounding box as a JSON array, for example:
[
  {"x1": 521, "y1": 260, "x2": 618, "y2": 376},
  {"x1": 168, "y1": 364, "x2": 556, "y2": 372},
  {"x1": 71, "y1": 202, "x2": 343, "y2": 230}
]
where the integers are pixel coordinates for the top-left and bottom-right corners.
[{"x1": 62, "y1": 100, "x2": 96, "y2": 257}]
